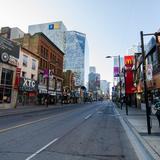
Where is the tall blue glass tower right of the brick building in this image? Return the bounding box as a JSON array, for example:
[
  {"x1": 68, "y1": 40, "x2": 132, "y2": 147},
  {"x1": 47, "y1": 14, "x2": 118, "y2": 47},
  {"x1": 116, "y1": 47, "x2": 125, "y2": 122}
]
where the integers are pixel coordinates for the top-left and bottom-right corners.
[{"x1": 64, "y1": 31, "x2": 89, "y2": 86}]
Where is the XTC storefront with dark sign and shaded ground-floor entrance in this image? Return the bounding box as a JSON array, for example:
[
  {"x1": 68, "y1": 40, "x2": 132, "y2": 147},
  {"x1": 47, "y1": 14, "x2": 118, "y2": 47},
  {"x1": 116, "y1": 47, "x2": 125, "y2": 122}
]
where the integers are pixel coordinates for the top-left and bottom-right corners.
[{"x1": 17, "y1": 78, "x2": 37, "y2": 105}]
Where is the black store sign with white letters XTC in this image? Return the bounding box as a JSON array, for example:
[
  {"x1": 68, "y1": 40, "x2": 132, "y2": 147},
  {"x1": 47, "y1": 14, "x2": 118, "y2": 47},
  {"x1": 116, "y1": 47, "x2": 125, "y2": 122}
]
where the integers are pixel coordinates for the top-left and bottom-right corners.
[{"x1": 20, "y1": 78, "x2": 37, "y2": 91}]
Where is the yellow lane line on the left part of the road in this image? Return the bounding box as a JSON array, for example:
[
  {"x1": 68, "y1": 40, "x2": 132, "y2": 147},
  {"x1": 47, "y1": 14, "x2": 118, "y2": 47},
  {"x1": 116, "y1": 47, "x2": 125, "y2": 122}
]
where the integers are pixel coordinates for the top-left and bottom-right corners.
[{"x1": 0, "y1": 116, "x2": 54, "y2": 133}]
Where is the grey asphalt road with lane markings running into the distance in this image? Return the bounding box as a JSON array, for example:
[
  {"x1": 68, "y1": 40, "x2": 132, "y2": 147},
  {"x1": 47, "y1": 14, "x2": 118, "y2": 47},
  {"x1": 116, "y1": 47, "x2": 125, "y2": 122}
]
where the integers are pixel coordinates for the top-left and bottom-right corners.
[{"x1": 0, "y1": 102, "x2": 137, "y2": 160}]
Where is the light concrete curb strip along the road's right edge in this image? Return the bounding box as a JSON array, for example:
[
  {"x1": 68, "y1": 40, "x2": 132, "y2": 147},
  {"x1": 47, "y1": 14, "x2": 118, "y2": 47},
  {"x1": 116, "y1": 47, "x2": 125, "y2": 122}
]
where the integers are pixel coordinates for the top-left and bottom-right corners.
[{"x1": 112, "y1": 103, "x2": 160, "y2": 160}]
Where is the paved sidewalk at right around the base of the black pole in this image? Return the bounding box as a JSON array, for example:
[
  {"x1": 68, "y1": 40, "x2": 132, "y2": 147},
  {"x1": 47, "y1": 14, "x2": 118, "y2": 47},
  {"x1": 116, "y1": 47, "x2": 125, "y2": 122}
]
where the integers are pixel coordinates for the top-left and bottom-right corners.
[{"x1": 116, "y1": 105, "x2": 160, "y2": 159}]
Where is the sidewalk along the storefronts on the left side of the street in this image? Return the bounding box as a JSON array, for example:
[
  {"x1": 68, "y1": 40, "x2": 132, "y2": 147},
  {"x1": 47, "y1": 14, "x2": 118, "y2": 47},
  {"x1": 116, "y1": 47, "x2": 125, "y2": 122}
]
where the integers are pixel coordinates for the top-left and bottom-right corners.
[{"x1": 0, "y1": 103, "x2": 74, "y2": 117}]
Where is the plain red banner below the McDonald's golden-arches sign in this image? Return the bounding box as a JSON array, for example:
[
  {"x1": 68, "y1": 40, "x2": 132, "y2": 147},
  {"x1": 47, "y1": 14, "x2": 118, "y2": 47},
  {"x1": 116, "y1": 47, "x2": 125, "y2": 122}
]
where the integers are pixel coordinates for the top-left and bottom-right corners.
[{"x1": 125, "y1": 69, "x2": 136, "y2": 95}]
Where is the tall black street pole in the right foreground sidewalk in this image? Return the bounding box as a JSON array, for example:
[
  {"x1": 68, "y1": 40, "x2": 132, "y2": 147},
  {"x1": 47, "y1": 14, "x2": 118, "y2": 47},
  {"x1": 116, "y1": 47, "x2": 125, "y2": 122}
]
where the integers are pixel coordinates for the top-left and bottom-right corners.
[{"x1": 140, "y1": 31, "x2": 151, "y2": 134}]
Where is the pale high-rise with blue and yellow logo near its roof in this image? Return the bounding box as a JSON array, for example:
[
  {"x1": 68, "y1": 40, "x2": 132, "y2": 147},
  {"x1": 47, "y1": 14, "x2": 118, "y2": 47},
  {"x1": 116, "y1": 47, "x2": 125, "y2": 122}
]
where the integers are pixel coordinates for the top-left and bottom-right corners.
[{"x1": 28, "y1": 21, "x2": 67, "y2": 52}]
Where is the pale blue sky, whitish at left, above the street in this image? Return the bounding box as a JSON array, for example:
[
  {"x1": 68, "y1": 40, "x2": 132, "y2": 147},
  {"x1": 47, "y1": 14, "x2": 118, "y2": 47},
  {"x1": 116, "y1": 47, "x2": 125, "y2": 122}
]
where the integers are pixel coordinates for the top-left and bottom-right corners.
[{"x1": 0, "y1": 0, "x2": 160, "y2": 82}]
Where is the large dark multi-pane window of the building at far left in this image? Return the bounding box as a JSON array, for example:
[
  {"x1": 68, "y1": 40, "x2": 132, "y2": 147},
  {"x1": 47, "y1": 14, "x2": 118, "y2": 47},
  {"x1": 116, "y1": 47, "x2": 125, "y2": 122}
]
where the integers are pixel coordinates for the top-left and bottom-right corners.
[{"x1": 0, "y1": 68, "x2": 13, "y2": 103}]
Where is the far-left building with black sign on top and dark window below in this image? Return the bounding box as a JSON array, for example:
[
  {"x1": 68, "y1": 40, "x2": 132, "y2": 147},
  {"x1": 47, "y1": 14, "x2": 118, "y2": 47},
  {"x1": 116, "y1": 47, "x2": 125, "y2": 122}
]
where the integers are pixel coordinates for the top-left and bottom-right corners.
[{"x1": 0, "y1": 36, "x2": 19, "y2": 108}]
